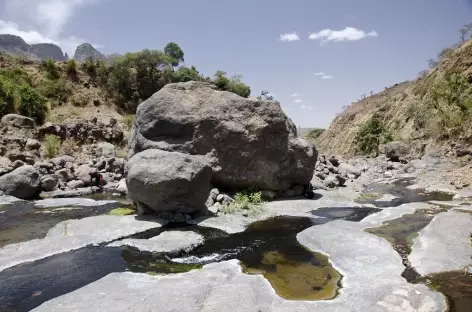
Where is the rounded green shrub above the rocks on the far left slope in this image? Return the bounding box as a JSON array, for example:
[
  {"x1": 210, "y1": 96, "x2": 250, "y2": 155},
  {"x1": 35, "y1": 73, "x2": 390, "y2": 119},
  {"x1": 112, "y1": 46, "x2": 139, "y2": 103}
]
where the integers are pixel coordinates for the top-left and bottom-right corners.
[{"x1": 18, "y1": 85, "x2": 48, "y2": 124}]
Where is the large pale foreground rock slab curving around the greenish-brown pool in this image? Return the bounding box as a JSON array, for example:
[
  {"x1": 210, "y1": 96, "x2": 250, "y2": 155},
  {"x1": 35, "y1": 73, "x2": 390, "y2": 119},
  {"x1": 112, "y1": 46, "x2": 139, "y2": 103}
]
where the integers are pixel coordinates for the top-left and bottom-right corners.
[{"x1": 33, "y1": 220, "x2": 446, "y2": 312}]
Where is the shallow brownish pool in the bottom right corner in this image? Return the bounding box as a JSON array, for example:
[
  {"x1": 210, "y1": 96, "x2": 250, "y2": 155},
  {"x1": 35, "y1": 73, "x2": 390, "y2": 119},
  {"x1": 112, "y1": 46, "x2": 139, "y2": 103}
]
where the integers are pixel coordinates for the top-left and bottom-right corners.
[{"x1": 416, "y1": 271, "x2": 472, "y2": 312}]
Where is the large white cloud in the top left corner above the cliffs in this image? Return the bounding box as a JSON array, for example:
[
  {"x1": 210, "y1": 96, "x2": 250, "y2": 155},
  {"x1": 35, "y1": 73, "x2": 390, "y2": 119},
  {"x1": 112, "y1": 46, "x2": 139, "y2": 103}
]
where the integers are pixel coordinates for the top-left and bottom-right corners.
[{"x1": 0, "y1": 0, "x2": 104, "y2": 54}]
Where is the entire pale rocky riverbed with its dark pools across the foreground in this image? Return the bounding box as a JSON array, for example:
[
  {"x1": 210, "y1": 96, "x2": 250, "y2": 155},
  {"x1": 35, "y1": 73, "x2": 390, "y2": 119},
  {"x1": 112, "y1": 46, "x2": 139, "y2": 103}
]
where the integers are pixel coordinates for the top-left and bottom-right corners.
[{"x1": 0, "y1": 160, "x2": 472, "y2": 312}]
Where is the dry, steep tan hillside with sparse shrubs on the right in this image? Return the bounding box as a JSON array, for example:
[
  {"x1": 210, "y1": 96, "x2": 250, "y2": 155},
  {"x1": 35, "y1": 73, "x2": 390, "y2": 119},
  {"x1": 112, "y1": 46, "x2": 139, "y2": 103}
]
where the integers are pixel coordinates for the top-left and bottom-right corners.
[{"x1": 316, "y1": 40, "x2": 472, "y2": 156}]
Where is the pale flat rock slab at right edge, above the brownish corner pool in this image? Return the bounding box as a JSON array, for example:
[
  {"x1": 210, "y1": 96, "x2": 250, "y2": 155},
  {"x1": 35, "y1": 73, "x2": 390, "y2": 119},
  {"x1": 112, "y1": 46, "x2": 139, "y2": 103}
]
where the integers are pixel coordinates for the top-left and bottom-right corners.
[{"x1": 408, "y1": 210, "x2": 472, "y2": 275}]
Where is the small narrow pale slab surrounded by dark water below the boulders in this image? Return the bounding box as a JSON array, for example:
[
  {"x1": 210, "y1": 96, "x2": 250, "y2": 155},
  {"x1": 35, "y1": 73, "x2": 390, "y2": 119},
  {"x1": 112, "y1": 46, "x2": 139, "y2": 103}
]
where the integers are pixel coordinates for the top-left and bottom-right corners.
[{"x1": 108, "y1": 231, "x2": 204, "y2": 253}]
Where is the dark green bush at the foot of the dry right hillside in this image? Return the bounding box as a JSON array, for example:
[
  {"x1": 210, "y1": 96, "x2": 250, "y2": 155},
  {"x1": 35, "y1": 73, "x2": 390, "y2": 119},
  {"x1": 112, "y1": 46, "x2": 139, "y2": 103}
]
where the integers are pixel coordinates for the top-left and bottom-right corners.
[{"x1": 356, "y1": 116, "x2": 393, "y2": 157}]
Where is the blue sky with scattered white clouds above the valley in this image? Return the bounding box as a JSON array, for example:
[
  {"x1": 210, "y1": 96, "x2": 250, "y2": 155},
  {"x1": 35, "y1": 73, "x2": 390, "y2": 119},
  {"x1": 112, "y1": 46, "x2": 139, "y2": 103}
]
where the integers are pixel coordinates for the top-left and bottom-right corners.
[{"x1": 0, "y1": 0, "x2": 472, "y2": 127}]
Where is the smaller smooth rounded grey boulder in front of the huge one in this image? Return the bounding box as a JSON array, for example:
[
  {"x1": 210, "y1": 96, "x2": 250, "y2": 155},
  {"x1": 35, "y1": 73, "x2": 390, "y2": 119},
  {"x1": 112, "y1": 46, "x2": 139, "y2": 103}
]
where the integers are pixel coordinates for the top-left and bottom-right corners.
[{"x1": 125, "y1": 149, "x2": 211, "y2": 213}]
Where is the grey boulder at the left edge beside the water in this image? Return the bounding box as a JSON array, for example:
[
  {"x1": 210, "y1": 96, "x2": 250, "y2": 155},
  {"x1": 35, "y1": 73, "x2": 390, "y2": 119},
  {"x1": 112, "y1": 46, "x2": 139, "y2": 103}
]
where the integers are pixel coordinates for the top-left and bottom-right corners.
[{"x1": 0, "y1": 166, "x2": 41, "y2": 199}]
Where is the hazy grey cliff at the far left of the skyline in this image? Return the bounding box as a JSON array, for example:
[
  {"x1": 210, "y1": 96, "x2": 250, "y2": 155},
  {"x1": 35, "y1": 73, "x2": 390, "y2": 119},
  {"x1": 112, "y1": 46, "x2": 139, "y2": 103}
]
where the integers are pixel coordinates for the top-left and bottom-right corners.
[{"x1": 0, "y1": 35, "x2": 66, "y2": 61}]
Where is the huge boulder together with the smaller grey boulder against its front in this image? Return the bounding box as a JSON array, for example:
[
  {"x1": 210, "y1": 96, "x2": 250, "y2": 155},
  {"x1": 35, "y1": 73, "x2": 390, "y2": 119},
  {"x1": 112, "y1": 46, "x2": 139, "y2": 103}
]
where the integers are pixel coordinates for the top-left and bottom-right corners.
[{"x1": 126, "y1": 82, "x2": 317, "y2": 218}]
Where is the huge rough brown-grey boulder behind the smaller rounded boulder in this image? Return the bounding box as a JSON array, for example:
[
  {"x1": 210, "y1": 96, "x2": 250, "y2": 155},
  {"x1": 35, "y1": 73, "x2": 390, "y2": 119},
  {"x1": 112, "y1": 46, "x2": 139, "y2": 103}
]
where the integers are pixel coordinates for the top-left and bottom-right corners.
[{"x1": 129, "y1": 82, "x2": 317, "y2": 191}]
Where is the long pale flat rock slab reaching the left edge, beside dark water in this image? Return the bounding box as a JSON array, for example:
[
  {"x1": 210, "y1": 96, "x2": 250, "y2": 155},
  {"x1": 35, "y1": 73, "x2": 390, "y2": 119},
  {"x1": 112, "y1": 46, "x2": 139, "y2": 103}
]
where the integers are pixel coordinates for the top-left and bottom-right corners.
[{"x1": 0, "y1": 216, "x2": 162, "y2": 271}]
